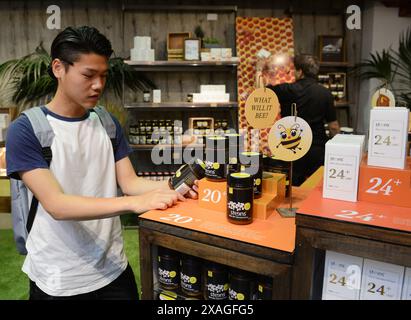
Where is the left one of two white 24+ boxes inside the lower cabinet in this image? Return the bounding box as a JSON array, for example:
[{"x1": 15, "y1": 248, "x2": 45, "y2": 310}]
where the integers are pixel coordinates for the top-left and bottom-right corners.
[{"x1": 322, "y1": 251, "x2": 363, "y2": 300}]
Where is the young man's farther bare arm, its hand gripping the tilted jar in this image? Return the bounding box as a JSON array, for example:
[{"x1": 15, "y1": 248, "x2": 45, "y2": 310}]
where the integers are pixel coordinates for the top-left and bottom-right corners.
[{"x1": 116, "y1": 157, "x2": 197, "y2": 199}]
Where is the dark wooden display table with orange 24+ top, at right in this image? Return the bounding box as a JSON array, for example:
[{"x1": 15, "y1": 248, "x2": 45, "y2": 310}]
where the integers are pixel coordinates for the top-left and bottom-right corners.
[{"x1": 292, "y1": 182, "x2": 411, "y2": 299}]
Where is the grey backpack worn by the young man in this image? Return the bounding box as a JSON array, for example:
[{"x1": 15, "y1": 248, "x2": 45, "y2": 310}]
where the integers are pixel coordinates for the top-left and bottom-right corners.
[{"x1": 10, "y1": 107, "x2": 116, "y2": 255}]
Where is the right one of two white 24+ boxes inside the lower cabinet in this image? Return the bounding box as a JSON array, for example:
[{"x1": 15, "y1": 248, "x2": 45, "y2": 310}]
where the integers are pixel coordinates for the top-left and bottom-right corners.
[{"x1": 360, "y1": 259, "x2": 404, "y2": 300}]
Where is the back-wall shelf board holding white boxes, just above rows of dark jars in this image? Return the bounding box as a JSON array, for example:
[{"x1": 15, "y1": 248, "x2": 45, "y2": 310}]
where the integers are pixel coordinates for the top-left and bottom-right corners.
[{"x1": 124, "y1": 101, "x2": 238, "y2": 109}]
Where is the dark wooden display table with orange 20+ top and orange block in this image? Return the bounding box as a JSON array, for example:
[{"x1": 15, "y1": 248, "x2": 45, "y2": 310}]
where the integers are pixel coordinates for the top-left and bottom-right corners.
[{"x1": 139, "y1": 173, "x2": 306, "y2": 299}]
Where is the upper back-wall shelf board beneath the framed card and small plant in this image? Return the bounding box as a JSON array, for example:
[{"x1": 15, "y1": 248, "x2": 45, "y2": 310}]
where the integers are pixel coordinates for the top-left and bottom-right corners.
[{"x1": 124, "y1": 60, "x2": 238, "y2": 71}]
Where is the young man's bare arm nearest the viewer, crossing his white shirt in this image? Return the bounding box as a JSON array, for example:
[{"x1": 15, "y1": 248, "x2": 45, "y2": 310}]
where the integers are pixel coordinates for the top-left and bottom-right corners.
[{"x1": 20, "y1": 169, "x2": 185, "y2": 220}]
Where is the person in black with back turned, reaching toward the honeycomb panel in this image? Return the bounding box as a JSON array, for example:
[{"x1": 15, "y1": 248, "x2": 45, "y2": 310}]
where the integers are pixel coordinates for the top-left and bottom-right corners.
[{"x1": 255, "y1": 54, "x2": 340, "y2": 186}]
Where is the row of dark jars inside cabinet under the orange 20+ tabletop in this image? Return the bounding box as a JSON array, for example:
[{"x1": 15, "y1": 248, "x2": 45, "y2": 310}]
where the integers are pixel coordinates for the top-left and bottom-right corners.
[{"x1": 157, "y1": 247, "x2": 272, "y2": 300}]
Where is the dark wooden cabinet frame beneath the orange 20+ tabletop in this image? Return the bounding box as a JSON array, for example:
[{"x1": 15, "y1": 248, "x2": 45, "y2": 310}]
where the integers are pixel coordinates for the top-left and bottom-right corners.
[{"x1": 139, "y1": 219, "x2": 293, "y2": 300}]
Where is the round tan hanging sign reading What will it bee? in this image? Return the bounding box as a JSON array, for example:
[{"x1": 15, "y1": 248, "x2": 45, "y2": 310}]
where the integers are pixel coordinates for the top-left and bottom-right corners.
[{"x1": 245, "y1": 88, "x2": 280, "y2": 129}]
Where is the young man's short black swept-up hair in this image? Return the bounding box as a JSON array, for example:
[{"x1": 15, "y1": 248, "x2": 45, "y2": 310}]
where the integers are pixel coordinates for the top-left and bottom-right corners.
[{"x1": 49, "y1": 26, "x2": 113, "y2": 78}]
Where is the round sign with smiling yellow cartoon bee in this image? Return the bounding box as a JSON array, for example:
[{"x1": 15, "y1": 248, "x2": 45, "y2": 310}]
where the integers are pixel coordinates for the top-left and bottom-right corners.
[{"x1": 268, "y1": 116, "x2": 313, "y2": 161}]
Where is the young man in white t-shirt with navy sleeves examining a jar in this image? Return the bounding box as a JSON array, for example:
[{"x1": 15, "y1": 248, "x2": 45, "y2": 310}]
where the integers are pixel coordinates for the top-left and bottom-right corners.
[{"x1": 6, "y1": 26, "x2": 196, "y2": 299}]
